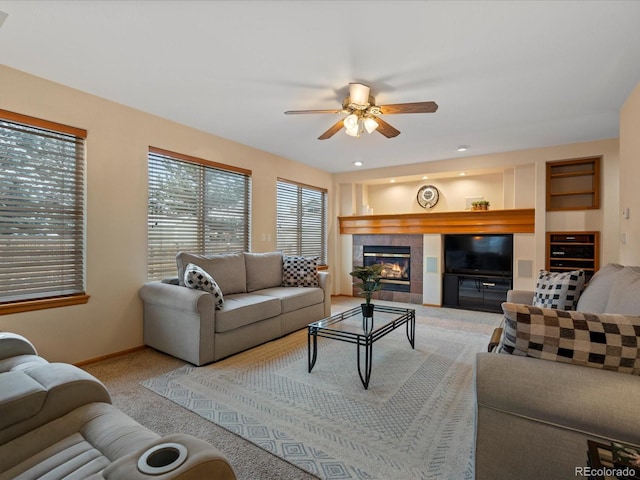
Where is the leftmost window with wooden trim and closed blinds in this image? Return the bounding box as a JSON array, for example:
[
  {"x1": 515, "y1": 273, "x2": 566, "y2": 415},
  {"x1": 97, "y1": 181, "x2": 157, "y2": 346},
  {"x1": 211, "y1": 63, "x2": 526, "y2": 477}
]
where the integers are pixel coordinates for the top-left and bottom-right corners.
[{"x1": 0, "y1": 110, "x2": 88, "y2": 313}]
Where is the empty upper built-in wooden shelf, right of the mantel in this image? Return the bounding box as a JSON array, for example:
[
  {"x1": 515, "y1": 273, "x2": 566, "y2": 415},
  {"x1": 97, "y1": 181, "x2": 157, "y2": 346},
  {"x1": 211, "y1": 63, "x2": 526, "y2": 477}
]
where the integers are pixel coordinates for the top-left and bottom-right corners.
[{"x1": 547, "y1": 157, "x2": 600, "y2": 211}]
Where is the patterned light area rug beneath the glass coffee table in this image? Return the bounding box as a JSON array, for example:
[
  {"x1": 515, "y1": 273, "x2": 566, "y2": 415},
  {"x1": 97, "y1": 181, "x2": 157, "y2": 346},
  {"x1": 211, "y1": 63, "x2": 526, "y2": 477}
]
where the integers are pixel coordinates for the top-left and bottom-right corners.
[{"x1": 142, "y1": 312, "x2": 496, "y2": 480}]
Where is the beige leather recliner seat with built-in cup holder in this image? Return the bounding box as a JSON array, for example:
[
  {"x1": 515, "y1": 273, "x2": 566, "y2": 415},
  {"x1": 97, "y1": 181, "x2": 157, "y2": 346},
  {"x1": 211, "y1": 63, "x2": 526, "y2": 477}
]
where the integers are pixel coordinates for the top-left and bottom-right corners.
[{"x1": 0, "y1": 332, "x2": 235, "y2": 480}]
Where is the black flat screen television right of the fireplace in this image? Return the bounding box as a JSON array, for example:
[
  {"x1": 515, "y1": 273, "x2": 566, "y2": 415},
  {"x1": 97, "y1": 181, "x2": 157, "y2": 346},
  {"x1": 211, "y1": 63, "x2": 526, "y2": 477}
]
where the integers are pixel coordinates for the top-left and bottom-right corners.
[{"x1": 444, "y1": 234, "x2": 513, "y2": 277}]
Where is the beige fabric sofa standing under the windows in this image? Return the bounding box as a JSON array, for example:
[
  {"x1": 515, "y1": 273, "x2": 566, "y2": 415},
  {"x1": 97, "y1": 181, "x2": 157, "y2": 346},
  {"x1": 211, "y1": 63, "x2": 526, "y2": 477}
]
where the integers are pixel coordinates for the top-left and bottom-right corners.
[{"x1": 140, "y1": 252, "x2": 331, "y2": 365}]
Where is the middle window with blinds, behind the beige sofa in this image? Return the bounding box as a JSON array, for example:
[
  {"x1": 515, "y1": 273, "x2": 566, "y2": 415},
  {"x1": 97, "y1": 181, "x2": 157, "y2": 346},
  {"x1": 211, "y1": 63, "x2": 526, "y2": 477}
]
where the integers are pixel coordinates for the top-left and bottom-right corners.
[{"x1": 147, "y1": 147, "x2": 251, "y2": 280}]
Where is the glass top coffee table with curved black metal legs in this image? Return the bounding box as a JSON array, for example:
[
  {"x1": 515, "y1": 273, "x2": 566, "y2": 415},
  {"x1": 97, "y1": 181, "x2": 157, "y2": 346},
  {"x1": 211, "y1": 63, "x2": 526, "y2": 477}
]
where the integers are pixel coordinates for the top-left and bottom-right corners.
[{"x1": 307, "y1": 305, "x2": 416, "y2": 390}]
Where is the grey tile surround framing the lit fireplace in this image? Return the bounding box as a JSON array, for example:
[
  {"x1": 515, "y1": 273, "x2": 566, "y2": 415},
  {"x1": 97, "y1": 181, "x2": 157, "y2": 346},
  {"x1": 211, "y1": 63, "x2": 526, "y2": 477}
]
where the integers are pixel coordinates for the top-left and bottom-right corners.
[{"x1": 353, "y1": 234, "x2": 423, "y2": 305}]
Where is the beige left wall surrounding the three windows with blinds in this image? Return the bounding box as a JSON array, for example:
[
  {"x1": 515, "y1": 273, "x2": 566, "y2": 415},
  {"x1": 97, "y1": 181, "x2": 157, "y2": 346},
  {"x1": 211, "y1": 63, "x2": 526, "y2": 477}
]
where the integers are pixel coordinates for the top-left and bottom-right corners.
[{"x1": 0, "y1": 66, "x2": 333, "y2": 362}]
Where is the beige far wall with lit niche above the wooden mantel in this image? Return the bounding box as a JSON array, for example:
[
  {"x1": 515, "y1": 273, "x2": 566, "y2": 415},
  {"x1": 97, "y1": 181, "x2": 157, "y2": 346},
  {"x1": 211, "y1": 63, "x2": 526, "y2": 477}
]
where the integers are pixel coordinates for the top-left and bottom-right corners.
[{"x1": 334, "y1": 138, "x2": 620, "y2": 293}]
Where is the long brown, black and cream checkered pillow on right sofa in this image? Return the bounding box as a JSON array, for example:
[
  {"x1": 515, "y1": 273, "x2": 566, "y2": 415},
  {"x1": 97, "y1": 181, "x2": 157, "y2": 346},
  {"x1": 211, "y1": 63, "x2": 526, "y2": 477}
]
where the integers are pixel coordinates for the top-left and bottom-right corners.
[{"x1": 498, "y1": 302, "x2": 640, "y2": 375}]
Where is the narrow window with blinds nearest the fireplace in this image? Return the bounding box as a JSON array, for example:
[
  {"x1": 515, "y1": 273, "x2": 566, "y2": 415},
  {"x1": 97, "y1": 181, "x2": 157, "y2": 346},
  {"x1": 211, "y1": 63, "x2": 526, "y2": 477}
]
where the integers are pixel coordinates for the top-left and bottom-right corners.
[{"x1": 277, "y1": 179, "x2": 327, "y2": 265}]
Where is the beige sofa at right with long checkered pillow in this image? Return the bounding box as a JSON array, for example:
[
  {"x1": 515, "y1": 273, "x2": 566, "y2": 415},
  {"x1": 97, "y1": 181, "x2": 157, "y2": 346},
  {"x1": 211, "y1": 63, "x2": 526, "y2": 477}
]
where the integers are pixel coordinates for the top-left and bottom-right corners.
[{"x1": 475, "y1": 264, "x2": 640, "y2": 480}]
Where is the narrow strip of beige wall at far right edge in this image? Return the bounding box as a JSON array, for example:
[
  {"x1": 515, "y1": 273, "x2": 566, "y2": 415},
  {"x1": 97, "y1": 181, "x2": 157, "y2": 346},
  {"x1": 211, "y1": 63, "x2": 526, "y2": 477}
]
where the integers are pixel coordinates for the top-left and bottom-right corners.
[{"x1": 616, "y1": 83, "x2": 640, "y2": 265}]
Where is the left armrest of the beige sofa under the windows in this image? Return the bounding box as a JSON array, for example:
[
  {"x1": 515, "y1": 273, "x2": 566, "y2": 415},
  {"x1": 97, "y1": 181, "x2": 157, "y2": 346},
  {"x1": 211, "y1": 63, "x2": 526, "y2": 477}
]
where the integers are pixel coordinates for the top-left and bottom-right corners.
[{"x1": 140, "y1": 282, "x2": 215, "y2": 365}]
